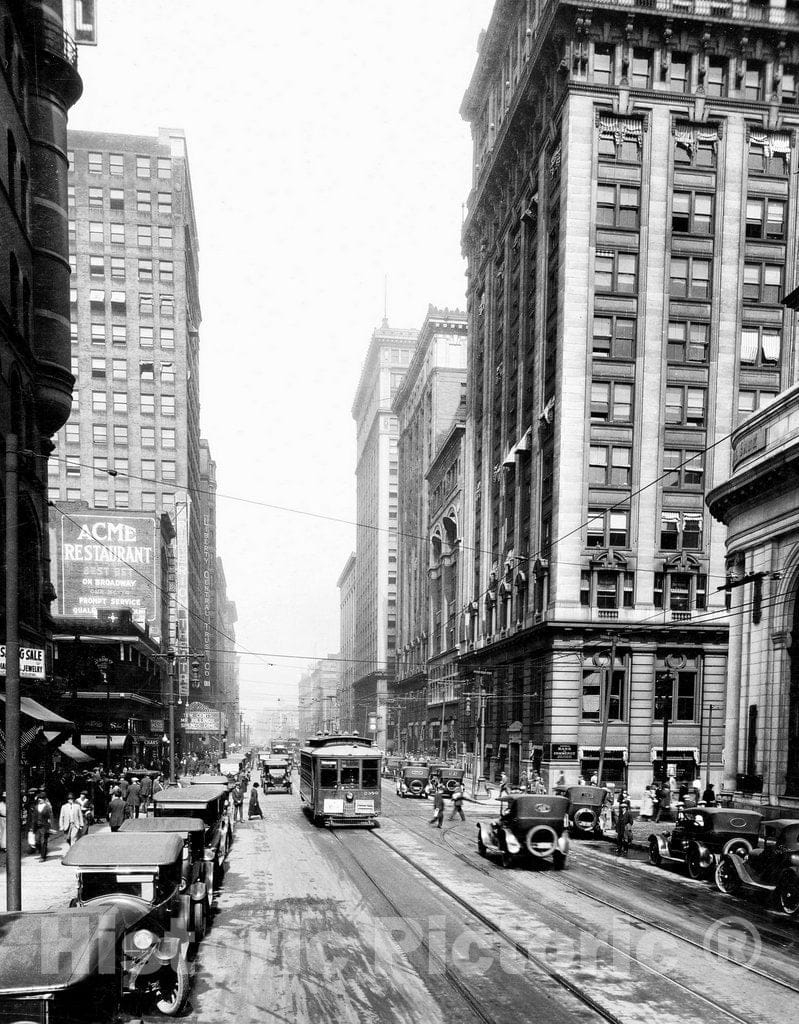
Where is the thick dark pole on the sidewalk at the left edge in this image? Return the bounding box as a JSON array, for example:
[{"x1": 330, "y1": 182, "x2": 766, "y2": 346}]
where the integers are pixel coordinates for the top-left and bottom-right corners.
[{"x1": 5, "y1": 434, "x2": 23, "y2": 910}]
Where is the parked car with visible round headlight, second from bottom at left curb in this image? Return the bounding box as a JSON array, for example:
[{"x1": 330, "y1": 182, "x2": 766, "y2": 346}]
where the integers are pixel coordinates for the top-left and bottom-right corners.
[{"x1": 61, "y1": 833, "x2": 190, "y2": 1017}]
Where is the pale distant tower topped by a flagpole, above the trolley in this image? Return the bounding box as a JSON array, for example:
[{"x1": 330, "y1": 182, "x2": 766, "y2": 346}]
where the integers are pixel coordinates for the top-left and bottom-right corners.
[{"x1": 350, "y1": 319, "x2": 418, "y2": 749}]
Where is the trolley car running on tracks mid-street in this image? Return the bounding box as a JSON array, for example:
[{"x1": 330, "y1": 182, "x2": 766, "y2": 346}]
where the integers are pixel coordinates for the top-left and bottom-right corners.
[{"x1": 300, "y1": 735, "x2": 383, "y2": 825}]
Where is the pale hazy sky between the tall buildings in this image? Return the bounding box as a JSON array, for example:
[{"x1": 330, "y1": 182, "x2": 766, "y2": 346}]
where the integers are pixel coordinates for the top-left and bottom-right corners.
[{"x1": 70, "y1": 0, "x2": 493, "y2": 710}]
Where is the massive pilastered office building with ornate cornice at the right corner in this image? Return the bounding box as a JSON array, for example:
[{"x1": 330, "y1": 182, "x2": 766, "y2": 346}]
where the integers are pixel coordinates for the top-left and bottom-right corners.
[{"x1": 454, "y1": 0, "x2": 799, "y2": 790}]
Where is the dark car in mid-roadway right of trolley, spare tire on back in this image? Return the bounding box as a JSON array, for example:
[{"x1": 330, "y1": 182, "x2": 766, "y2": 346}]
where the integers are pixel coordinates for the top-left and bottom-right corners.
[{"x1": 477, "y1": 794, "x2": 569, "y2": 870}]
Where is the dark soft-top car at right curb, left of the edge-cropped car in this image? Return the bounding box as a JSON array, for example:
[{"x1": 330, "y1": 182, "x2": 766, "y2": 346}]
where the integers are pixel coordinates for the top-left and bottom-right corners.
[{"x1": 649, "y1": 807, "x2": 763, "y2": 879}]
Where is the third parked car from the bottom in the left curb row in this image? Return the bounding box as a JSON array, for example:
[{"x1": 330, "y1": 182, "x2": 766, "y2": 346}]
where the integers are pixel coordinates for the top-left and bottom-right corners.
[{"x1": 120, "y1": 817, "x2": 214, "y2": 942}]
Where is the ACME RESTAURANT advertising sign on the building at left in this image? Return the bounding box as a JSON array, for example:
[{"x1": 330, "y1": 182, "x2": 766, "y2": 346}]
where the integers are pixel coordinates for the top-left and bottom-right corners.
[{"x1": 54, "y1": 512, "x2": 159, "y2": 627}]
